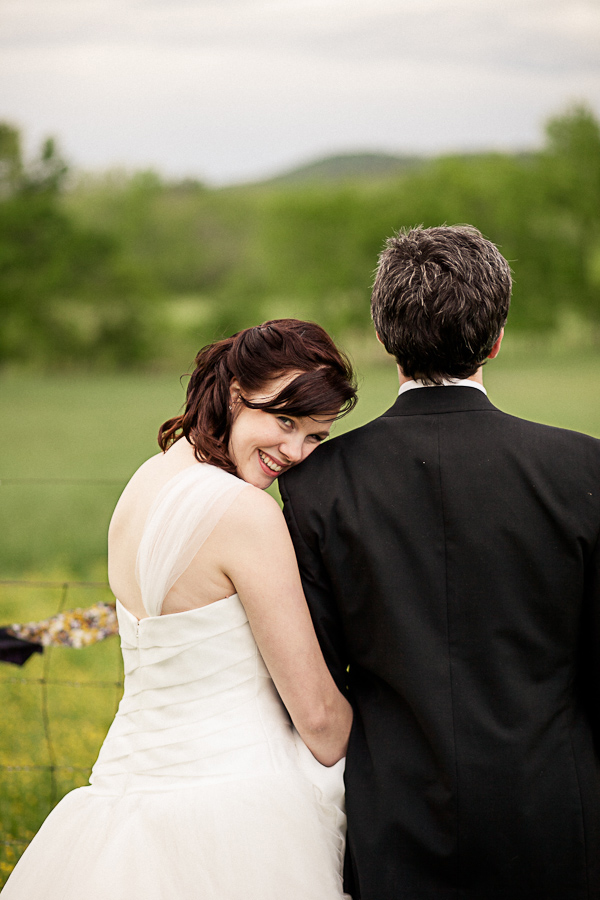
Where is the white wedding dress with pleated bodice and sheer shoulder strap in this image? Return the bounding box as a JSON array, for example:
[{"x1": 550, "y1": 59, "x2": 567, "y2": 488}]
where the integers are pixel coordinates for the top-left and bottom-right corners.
[{"x1": 3, "y1": 464, "x2": 345, "y2": 900}]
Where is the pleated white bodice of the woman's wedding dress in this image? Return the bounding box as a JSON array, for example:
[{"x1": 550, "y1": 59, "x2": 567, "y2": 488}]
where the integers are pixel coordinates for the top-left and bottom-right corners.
[{"x1": 90, "y1": 594, "x2": 296, "y2": 793}]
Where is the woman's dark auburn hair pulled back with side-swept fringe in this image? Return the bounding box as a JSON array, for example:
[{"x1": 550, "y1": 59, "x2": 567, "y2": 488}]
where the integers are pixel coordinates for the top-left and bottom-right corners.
[{"x1": 158, "y1": 319, "x2": 358, "y2": 475}]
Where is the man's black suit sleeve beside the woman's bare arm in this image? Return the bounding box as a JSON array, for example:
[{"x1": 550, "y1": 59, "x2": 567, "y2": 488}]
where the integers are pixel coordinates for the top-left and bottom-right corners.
[{"x1": 279, "y1": 479, "x2": 348, "y2": 693}]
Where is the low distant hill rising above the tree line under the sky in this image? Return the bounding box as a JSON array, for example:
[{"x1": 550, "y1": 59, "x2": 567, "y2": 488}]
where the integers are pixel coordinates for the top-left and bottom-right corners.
[{"x1": 262, "y1": 153, "x2": 425, "y2": 184}]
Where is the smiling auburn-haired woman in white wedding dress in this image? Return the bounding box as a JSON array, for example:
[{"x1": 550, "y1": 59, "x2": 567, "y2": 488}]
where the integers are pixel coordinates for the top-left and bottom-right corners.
[{"x1": 3, "y1": 319, "x2": 356, "y2": 900}]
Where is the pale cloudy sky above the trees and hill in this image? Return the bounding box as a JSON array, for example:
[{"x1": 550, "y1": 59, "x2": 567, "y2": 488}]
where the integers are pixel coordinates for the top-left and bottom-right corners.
[{"x1": 0, "y1": 0, "x2": 600, "y2": 185}]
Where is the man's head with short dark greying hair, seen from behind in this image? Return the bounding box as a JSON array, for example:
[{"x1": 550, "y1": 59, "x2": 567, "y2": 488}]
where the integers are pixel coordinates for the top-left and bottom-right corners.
[{"x1": 371, "y1": 225, "x2": 511, "y2": 384}]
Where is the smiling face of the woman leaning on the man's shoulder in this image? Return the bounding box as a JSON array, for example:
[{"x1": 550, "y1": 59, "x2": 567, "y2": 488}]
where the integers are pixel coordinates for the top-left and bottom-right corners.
[{"x1": 228, "y1": 372, "x2": 334, "y2": 490}]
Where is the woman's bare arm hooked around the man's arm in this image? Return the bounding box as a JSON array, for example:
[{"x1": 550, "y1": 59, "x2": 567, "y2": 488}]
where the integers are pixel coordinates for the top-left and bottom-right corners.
[{"x1": 213, "y1": 488, "x2": 352, "y2": 766}]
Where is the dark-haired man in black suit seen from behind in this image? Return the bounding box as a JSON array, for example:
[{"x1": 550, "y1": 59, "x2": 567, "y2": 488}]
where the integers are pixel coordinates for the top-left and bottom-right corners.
[{"x1": 280, "y1": 226, "x2": 600, "y2": 900}]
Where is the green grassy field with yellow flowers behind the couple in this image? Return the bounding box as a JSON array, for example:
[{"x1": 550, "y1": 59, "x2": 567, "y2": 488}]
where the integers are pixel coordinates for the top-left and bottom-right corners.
[{"x1": 0, "y1": 344, "x2": 600, "y2": 884}]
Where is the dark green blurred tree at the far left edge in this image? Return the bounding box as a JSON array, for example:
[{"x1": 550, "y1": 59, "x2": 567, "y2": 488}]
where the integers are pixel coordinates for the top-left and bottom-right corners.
[{"x1": 0, "y1": 124, "x2": 157, "y2": 365}]
